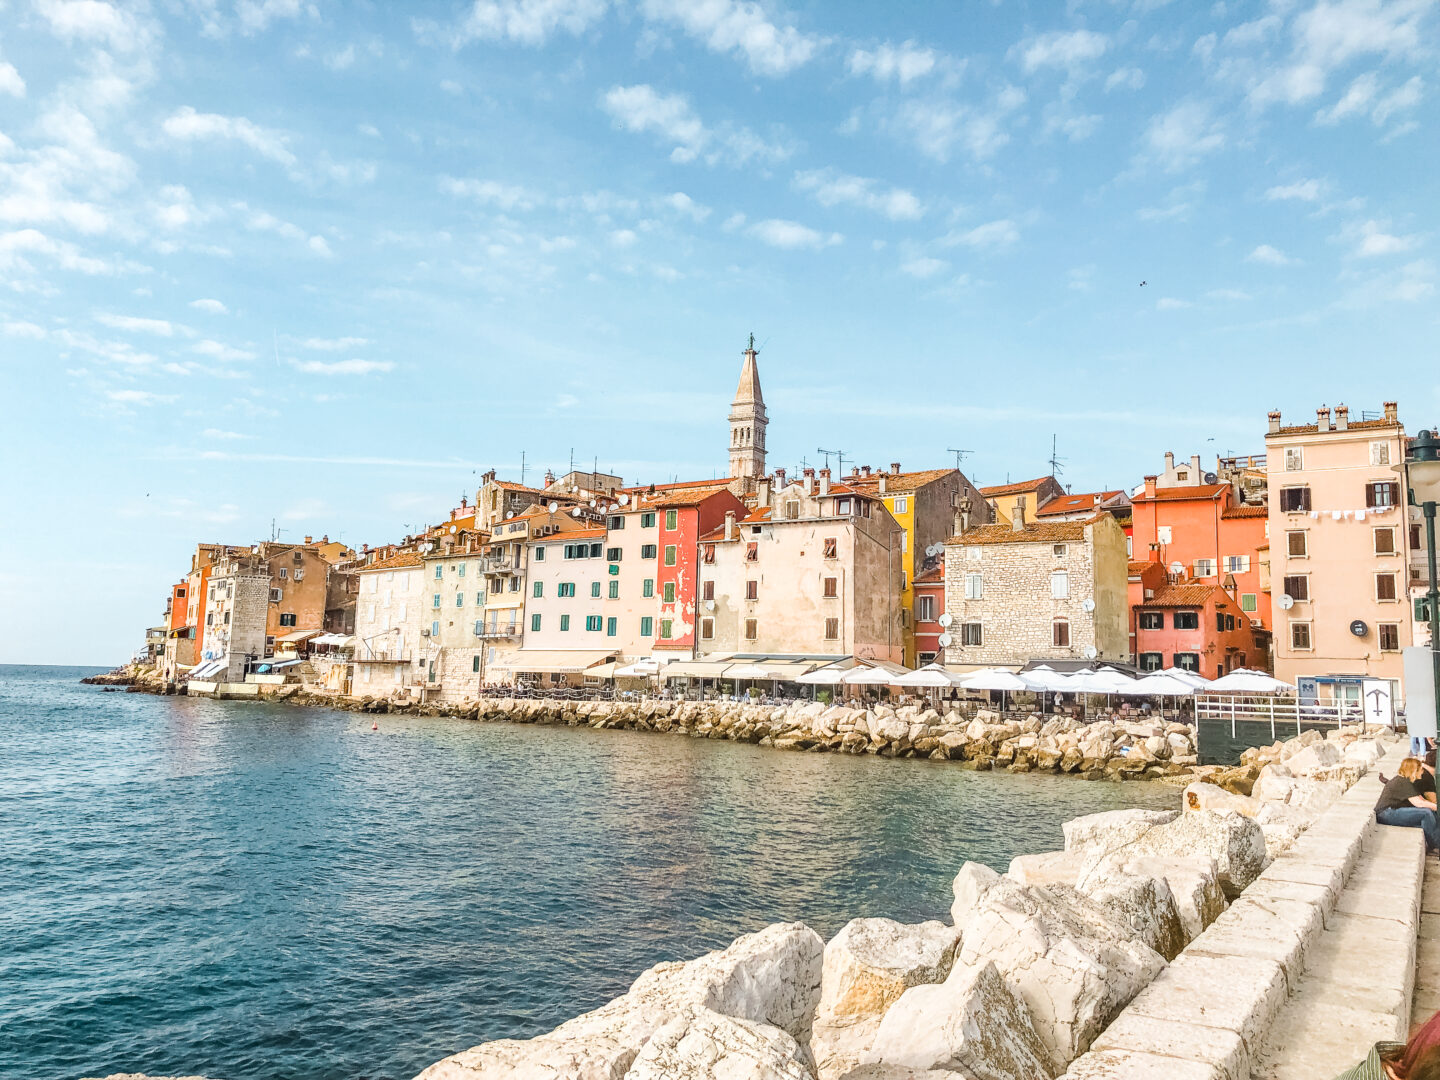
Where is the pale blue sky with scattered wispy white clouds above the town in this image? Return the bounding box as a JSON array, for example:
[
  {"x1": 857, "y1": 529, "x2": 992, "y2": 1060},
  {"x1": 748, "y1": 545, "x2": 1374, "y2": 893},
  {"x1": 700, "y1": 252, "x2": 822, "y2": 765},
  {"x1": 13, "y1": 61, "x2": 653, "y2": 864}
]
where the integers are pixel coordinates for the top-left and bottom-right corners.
[{"x1": 0, "y1": 0, "x2": 1440, "y2": 662}]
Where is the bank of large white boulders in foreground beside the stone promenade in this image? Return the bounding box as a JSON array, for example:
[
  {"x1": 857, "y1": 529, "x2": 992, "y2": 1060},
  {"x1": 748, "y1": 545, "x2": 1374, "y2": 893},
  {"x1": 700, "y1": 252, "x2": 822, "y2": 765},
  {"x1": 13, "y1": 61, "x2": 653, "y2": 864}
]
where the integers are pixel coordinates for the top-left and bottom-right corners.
[{"x1": 408, "y1": 727, "x2": 1381, "y2": 1080}]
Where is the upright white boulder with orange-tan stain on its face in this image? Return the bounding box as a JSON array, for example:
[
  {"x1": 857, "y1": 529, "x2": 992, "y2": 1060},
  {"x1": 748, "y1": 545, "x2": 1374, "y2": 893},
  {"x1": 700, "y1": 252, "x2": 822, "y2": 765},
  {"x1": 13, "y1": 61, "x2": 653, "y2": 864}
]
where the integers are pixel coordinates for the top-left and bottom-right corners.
[{"x1": 811, "y1": 919, "x2": 960, "y2": 1080}]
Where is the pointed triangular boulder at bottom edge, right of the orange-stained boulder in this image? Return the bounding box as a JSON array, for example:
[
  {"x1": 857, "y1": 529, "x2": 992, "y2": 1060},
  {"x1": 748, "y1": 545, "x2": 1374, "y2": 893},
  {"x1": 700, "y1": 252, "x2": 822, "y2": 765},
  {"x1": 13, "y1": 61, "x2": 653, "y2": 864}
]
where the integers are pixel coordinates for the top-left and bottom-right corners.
[{"x1": 865, "y1": 963, "x2": 1054, "y2": 1080}]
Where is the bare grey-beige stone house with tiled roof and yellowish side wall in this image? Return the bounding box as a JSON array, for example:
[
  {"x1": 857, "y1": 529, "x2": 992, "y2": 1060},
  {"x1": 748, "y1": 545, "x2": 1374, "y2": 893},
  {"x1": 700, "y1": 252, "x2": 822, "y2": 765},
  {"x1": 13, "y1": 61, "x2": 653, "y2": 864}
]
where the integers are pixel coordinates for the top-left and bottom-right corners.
[{"x1": 945, "y1": 503, "x2": 1129, "y2": 667}]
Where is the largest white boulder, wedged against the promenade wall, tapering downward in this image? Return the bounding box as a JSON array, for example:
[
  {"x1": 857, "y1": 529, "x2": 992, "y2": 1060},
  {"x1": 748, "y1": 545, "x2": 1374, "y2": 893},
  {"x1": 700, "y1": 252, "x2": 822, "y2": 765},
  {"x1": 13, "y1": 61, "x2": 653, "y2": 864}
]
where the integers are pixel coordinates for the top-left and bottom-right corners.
[{"x1": 952, "y1": 863, "x2": 1165, "y2": 1073}]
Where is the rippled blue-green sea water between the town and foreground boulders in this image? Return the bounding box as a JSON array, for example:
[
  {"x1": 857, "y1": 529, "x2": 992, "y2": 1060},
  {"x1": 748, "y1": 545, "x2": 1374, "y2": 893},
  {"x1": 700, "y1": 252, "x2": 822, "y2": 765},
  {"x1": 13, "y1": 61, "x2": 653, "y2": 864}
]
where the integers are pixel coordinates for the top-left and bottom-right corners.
[{"x1": 0, "y1": 667, "x2": 1176, "y2": 1080}]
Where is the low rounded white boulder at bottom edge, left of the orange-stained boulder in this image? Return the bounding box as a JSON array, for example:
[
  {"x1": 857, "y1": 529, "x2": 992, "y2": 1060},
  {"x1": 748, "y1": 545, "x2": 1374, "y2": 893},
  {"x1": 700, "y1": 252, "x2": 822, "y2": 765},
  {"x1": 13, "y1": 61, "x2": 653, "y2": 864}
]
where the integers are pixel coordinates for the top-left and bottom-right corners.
[{"x1": 625, "y1": 1005, "x2": 811, "y2": 1080}]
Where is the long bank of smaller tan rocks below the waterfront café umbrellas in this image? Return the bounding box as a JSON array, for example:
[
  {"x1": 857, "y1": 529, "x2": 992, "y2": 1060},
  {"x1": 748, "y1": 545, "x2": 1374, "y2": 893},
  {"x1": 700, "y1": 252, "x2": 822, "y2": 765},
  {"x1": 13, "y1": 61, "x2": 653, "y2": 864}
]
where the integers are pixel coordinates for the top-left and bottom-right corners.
[{"x1": 336, "y1": 697, "x2": 1214, "y2": 779}]
